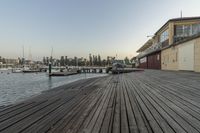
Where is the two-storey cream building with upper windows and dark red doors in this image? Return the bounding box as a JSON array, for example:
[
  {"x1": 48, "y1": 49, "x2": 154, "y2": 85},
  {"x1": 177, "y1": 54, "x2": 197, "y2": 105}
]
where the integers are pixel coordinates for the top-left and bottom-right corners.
[{"x1": 137, "y1": 17, "x2": 200, "y2": 72}]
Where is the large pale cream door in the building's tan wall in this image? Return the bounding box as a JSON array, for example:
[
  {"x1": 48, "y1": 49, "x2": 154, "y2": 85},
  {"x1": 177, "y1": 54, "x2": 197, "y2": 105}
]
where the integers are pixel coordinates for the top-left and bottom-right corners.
[{"x1": 178, "y1": 42, "x2": 194, "y2": 71}]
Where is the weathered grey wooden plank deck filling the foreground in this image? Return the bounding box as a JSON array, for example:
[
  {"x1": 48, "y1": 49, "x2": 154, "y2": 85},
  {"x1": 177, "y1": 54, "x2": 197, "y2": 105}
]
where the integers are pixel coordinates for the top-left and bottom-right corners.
[{"x1": 0, "y1": 70, "x2": 200, "y2": 133}]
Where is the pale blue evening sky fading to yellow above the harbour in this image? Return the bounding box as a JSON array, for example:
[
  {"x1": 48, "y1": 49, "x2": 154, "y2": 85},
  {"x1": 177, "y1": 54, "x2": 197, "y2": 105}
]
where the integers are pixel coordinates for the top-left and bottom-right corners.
[{"x1": 0, "y1": 0, "x2": 200, "y2": 60}]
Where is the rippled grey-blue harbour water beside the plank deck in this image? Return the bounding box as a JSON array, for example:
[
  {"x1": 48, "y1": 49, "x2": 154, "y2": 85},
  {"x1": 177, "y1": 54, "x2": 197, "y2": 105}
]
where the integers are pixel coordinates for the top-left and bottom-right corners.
[{"x1": 0, "y1": 71, "x2": 106, "y2": 106}]
